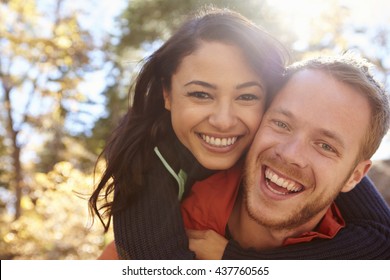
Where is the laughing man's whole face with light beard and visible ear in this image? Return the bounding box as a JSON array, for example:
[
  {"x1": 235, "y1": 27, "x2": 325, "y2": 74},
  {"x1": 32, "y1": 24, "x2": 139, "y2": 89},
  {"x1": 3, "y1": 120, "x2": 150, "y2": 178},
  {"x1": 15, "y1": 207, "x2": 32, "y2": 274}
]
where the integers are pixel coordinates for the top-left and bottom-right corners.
[{"x1": 244, "y1": 70, "x2": 371, "y2": 229}]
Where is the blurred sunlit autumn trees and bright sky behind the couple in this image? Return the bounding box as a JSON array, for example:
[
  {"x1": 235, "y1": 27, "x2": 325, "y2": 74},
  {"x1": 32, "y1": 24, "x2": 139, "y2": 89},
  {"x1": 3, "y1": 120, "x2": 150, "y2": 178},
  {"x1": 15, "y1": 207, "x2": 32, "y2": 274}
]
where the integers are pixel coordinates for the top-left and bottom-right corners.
[{"x1": 0, "y1": 0, "x2": 390, "y2": 259}]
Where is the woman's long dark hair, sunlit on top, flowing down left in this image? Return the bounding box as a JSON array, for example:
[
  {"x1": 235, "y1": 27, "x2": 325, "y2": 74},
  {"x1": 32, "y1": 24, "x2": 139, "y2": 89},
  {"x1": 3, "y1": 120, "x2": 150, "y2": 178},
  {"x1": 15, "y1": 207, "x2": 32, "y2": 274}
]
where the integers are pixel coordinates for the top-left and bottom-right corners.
[{"x1": 89, "y1": 8, "x2": 287, "y2": 230}]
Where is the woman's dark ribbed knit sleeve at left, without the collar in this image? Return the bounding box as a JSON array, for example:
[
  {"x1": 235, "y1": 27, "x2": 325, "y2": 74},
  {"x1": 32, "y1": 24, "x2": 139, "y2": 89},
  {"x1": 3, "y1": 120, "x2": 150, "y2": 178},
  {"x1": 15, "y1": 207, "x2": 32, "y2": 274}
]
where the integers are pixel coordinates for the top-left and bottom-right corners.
[{"x1": 114, "y1": 168, "x2": 195, "y2": 259}]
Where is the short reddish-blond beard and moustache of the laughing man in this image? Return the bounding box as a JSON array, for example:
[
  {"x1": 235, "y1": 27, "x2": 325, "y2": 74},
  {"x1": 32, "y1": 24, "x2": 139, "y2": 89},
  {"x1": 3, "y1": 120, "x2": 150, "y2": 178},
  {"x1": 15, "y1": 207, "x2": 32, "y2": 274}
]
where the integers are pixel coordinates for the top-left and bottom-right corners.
[{"x1": 243, "y1": 154, "x2": 354, "y2": 230}]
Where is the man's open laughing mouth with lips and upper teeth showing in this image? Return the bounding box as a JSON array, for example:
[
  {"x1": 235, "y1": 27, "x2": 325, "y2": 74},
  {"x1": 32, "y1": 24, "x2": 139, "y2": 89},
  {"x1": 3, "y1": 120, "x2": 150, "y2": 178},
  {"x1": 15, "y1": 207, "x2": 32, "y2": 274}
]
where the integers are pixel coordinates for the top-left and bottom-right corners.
[{"x1": 264, "y1": 166, "x2": 304, "y2": 195}]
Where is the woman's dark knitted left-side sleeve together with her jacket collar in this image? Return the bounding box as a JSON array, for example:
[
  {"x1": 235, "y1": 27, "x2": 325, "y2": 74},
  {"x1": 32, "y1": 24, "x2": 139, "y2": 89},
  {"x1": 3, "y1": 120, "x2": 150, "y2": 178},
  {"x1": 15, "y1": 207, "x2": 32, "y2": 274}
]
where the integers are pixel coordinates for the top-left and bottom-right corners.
[{"x1": 114, "y1": 137, "x2": 213, "y2": 260}]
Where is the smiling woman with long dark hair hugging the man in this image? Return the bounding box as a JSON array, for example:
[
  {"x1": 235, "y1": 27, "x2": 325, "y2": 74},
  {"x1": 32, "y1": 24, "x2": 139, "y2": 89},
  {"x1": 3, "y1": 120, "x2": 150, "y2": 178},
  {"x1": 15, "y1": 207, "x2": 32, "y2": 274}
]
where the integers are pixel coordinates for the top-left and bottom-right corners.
[{"x1": 90, "y1": 7, "x2": 388, "y2": 259}]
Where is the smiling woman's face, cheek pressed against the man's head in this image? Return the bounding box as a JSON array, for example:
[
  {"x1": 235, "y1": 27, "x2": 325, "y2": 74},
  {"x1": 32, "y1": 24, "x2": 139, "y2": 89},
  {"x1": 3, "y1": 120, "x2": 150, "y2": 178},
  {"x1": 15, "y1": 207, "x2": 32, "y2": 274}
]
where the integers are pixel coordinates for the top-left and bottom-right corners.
[{"x1": 164, "y1": 42, "x2": 266, "y2": 170}]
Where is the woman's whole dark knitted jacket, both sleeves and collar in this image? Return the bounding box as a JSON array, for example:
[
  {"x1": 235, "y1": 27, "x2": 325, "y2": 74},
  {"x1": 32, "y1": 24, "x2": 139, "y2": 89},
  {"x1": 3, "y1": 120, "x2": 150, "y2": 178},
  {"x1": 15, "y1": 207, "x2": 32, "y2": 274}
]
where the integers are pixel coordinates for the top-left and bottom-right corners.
[{"x1": 113, "y1": 139, "x2": 390, "y2": 259}]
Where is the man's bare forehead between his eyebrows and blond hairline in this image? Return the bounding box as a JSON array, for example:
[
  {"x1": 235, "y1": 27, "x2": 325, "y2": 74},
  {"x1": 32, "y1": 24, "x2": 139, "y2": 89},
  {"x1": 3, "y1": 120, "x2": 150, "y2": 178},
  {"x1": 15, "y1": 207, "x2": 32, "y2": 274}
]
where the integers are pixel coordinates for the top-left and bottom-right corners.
[{"x1": 268, "y1": 70, "x2": 371, "y2": 145}]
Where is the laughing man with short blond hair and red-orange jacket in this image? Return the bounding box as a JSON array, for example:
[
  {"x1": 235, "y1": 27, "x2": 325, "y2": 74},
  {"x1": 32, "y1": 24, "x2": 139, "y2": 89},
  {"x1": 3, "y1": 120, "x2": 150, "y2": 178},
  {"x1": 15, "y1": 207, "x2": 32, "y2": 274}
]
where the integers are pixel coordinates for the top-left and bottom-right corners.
[{"x1": 182, "y1": 53, "x2": 390, "y2": 259}]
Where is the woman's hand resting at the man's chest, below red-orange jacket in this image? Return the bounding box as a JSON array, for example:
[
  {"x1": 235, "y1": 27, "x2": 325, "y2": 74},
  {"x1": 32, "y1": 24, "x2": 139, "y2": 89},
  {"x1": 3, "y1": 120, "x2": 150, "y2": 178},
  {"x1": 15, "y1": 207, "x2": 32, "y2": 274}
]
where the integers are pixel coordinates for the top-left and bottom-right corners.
[{"x1": 186, "y1": 229, "x2": 228, "y2": 260}]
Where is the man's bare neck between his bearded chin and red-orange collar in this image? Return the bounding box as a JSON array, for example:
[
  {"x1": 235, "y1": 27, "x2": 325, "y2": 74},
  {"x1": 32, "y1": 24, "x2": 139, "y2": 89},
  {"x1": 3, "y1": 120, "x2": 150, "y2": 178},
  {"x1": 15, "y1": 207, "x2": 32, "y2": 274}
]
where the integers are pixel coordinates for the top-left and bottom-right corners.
[{"x1": 228, "y1": 192, "x2": 326, "y2": 250}]
